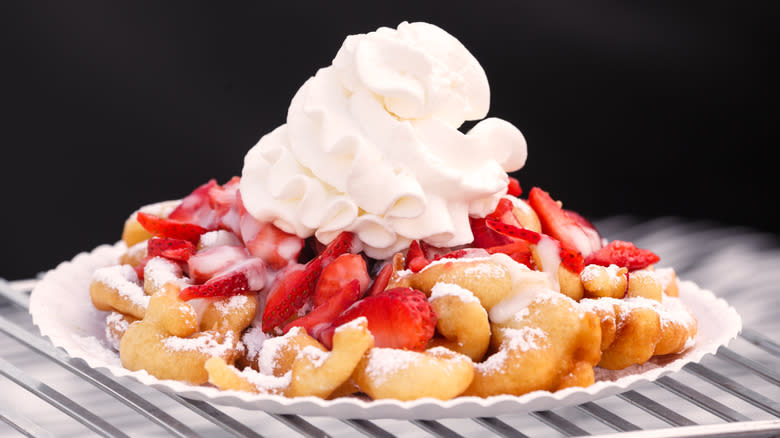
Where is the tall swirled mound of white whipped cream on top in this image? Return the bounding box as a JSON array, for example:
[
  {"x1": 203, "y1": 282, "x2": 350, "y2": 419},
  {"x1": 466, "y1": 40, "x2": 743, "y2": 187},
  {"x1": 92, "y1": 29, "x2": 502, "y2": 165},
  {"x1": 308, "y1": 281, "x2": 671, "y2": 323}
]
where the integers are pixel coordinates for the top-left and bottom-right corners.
[{"x1": 240, "y1": 22, "x2": 527, "y2": 259}]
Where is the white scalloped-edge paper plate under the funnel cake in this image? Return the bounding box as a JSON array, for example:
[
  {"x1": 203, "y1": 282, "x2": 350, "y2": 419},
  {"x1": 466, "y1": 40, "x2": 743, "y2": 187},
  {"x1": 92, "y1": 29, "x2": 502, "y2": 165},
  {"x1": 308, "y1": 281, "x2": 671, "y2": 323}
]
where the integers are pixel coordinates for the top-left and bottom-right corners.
[{"x1": 30, "y1": 243, "x2": 741, "y2": 419}]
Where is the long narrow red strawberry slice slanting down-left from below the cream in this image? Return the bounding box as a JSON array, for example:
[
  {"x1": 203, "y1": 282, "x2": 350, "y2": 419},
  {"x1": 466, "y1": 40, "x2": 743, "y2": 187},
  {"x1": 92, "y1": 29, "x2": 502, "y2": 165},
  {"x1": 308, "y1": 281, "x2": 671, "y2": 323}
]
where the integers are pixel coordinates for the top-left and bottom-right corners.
[{"x1": 262, "y1": 231, "x2": 353, "y2": 332}]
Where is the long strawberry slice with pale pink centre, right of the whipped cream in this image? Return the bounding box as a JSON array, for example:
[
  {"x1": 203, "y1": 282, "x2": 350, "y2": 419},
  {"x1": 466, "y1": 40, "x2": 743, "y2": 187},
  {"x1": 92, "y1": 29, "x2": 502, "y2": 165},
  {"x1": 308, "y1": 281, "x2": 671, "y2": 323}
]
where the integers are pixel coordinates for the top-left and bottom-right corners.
[{"x1": 528, "y1": 187, "x2": 601, "y2": 256}]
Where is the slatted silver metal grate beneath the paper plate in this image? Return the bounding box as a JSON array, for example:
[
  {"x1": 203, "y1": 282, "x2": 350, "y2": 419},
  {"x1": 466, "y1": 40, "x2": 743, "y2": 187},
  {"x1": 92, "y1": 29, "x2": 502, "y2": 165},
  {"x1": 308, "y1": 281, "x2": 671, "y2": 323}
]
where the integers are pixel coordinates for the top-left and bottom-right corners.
[{"x1": 0, "y1": 218, "x2": 780, "y2": 437}]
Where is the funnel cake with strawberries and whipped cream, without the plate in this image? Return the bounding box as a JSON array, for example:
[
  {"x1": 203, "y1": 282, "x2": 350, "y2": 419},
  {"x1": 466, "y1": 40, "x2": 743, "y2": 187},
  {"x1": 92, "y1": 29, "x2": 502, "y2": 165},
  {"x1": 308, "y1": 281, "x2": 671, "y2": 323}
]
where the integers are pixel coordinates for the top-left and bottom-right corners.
[{"x1": 82, "y1": 23, "x2": 697, "y2": 400}]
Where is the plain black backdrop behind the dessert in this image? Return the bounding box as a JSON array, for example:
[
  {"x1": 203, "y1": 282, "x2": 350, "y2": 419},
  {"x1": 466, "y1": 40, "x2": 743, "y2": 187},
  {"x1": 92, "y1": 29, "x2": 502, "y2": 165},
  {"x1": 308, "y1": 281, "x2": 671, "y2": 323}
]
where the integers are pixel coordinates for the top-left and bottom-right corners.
[{"x1": 0, "y1": 1, "x2": 780, "y2": 279}]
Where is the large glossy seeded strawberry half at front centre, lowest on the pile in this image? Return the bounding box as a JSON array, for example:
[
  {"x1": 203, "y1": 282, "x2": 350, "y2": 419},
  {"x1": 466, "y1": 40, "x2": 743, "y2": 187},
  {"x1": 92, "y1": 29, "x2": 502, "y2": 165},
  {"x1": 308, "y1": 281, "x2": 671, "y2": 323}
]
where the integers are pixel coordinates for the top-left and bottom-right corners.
[{"x1": 321, "y1": 287, "x2": 436, "y2": 351}]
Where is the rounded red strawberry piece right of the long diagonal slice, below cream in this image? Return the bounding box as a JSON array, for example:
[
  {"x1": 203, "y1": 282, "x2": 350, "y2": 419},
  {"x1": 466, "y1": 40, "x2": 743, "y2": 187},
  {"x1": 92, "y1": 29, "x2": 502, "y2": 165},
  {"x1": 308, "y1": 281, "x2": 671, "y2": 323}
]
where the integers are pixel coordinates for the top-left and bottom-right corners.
[{"x1": 312, "y1": 254, "x2": 371, "y2": 307}]
